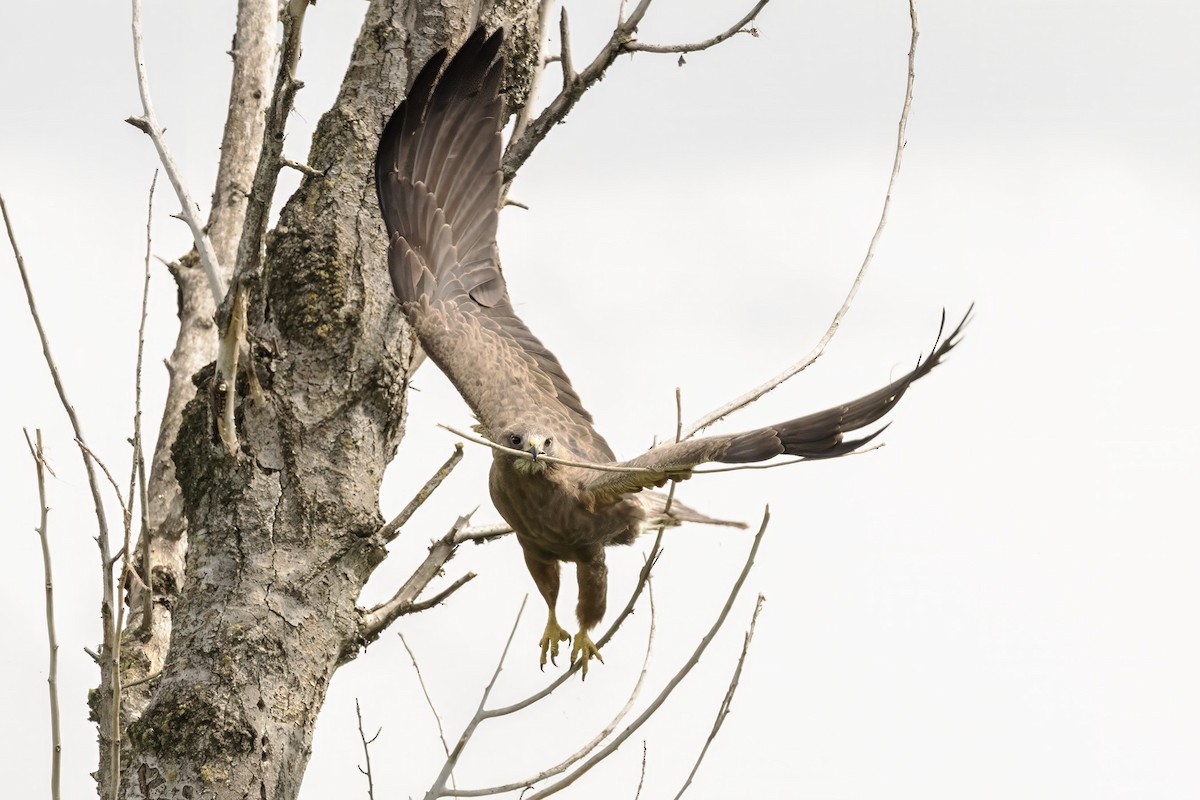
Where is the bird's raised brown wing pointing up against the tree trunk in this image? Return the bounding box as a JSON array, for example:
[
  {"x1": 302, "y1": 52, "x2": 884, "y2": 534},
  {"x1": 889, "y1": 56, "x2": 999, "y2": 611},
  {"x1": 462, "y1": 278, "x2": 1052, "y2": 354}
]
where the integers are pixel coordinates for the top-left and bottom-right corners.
[{"x1": 376, "y1": 29, "x2": 613, "y2": 461}]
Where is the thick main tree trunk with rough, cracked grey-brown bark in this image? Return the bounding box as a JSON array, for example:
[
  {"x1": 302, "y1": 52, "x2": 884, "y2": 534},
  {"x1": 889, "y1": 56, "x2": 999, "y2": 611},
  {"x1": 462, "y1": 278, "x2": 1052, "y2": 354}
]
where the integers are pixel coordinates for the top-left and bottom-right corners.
[{"x1": 120, "y1": 0, "x2": 539, "y2": 799}]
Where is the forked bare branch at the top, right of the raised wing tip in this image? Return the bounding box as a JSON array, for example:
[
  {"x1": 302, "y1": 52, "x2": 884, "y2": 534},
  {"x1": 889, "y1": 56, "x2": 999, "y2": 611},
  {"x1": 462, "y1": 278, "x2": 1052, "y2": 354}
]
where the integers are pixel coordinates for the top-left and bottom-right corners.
[{"x1": 503, "y1": 0, "x2": 767, "y2": 182}]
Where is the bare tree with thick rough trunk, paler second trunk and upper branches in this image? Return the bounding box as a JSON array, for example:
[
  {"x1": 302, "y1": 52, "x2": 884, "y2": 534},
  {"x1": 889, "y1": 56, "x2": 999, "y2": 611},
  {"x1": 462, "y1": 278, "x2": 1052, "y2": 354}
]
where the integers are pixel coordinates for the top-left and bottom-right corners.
[{"x1": 92, "y1": 0, "x2": 763, "y2": 798}]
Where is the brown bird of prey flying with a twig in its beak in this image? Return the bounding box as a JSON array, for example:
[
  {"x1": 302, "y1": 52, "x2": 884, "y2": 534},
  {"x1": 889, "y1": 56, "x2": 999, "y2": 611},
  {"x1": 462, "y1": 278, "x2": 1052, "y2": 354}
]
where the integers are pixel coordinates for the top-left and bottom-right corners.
[{"x1": 376, "y1": 29, "x2": 966, "y2": 675}]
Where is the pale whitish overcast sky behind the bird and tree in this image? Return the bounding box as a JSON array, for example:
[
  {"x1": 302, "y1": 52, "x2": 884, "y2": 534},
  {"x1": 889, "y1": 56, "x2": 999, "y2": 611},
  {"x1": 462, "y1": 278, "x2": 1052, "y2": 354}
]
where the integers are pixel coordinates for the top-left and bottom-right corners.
[{"x1": 0, "y1": 0, "x2": 1200, "y2": 800}]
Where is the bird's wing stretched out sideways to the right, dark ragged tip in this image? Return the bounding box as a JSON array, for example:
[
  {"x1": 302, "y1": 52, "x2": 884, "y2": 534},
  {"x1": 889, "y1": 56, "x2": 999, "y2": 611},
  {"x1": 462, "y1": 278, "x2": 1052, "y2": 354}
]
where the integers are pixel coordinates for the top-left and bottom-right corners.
[{"x1": 584, "y1": 311, "x2": 971, "y2": 505}]
